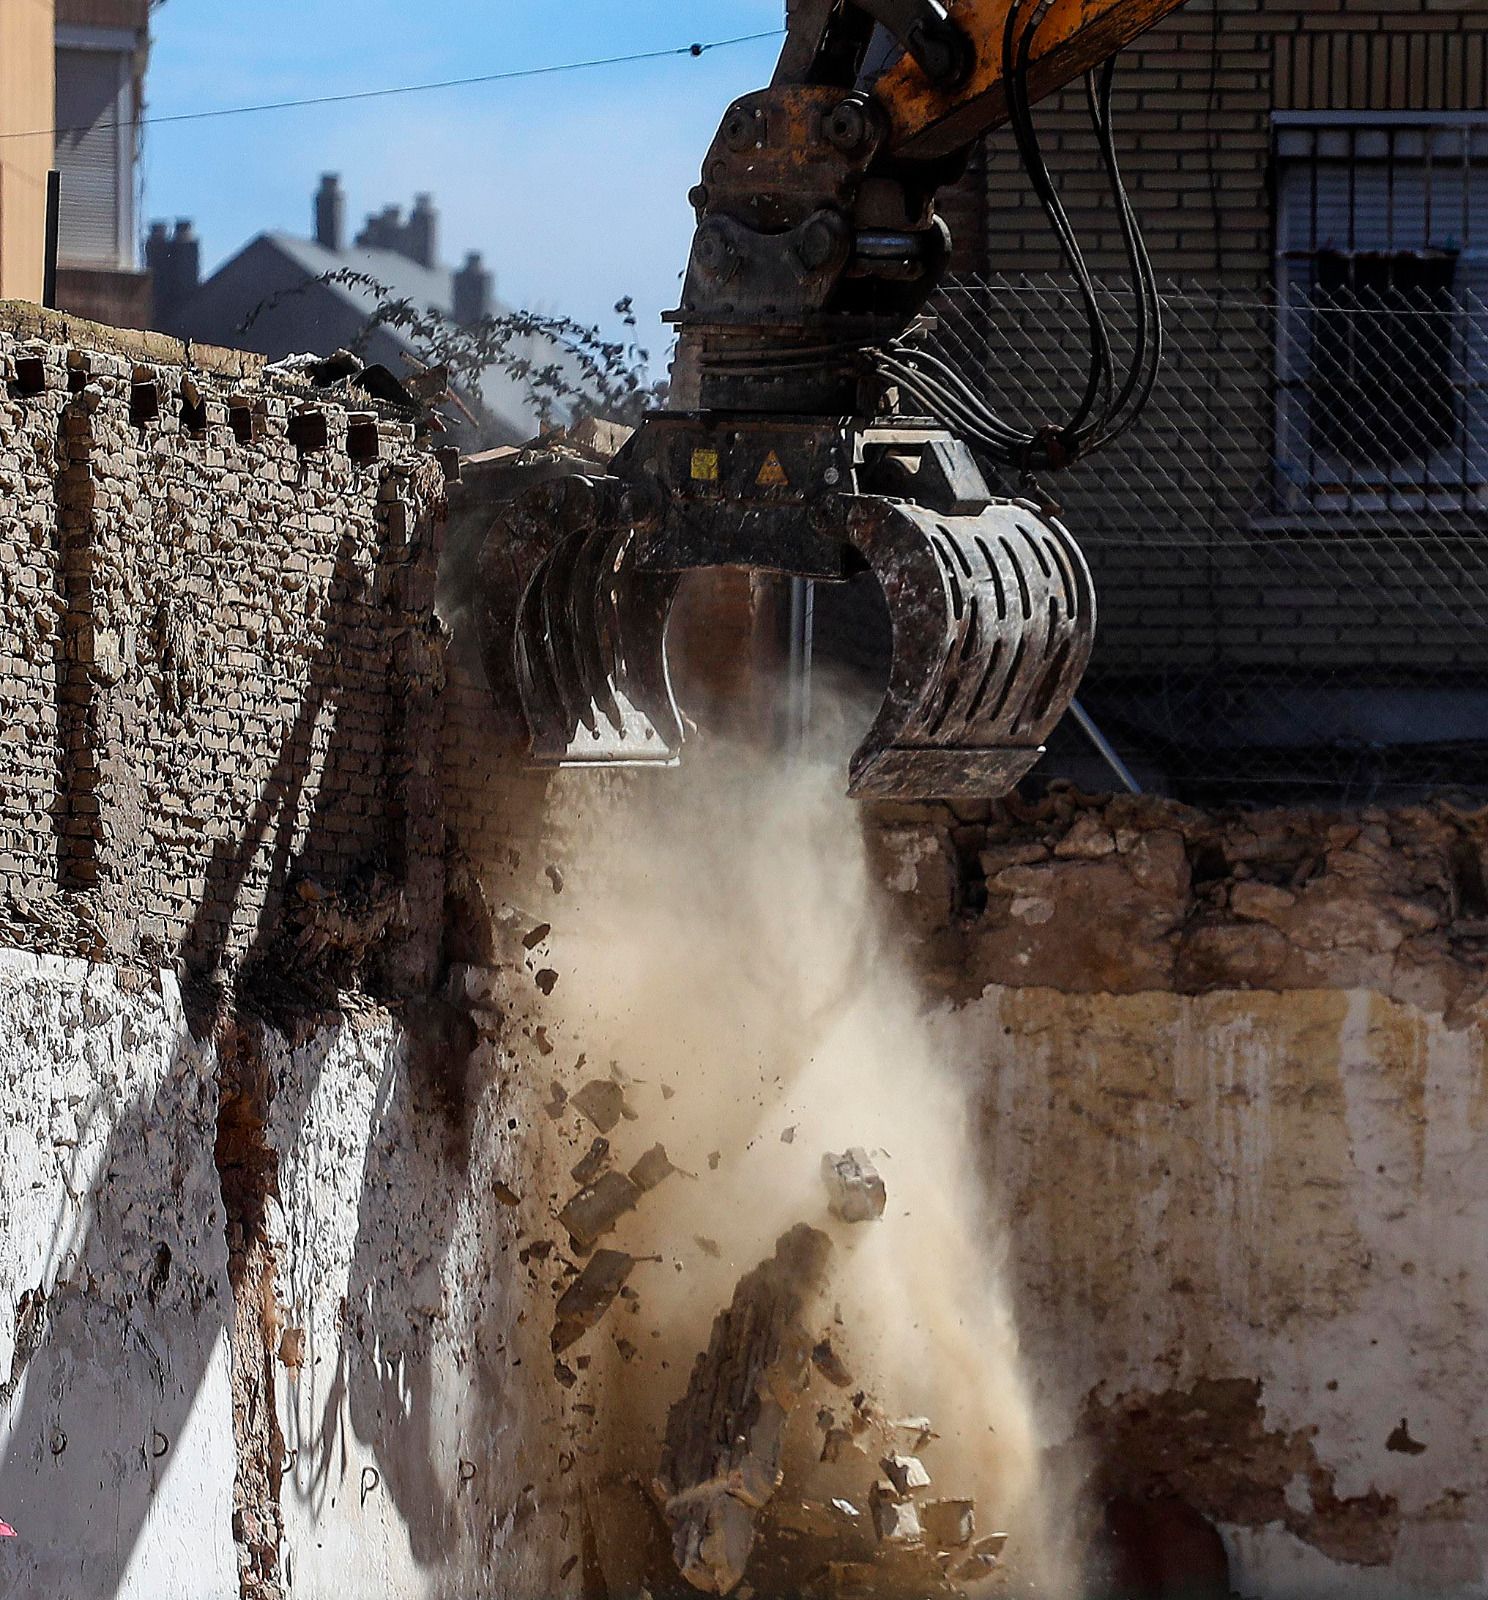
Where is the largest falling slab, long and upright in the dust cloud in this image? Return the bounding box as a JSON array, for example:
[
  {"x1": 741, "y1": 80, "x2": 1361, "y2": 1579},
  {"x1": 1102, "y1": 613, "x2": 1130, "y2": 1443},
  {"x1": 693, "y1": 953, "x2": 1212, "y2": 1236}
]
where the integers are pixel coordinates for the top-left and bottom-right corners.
[{"x1": 658, "y1": 1224, "x2": 832, "y2": 1594}]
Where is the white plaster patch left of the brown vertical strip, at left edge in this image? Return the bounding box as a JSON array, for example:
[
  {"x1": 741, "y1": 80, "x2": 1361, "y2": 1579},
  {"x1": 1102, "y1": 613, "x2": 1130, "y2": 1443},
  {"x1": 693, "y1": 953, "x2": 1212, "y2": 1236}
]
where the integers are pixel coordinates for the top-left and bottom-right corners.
[{"x1": 0, "y1": 952, "x2": 238, "y2": 1600}]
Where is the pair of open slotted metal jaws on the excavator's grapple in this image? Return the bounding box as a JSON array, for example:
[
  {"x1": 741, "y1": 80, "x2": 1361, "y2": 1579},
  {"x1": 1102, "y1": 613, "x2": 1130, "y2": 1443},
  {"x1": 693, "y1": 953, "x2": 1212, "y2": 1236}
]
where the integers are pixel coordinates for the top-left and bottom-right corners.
[{"x1": 480, "y1": 451, "x2": 1094, "y2": 798}]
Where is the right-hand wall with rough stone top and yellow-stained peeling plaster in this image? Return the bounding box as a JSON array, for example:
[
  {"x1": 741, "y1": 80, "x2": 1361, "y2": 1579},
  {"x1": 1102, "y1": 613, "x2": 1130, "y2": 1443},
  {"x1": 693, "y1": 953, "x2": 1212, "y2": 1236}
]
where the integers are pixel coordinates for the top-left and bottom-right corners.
[{"x1": 880, "y1": 790, "x2": 1488, "y2": 1600}]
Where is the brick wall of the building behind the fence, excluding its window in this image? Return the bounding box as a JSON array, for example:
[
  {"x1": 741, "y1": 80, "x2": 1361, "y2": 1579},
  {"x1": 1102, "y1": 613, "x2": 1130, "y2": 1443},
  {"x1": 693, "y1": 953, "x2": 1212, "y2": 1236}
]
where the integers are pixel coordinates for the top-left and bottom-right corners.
[{"x1": 944, "y1": 0, "x2": 1488, "y2": 778}]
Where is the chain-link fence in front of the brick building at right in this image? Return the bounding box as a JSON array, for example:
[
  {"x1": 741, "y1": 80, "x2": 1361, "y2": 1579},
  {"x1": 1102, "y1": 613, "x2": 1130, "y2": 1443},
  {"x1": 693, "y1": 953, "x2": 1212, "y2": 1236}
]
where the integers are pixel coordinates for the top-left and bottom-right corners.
[{"x1": 931, "y1": 278, "x2": 1488, "y2": 805}]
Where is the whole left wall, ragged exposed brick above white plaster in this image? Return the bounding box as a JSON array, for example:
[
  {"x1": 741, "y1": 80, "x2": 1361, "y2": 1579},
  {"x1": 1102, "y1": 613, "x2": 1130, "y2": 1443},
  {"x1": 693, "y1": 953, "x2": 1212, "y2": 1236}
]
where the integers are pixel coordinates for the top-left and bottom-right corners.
[{"x1": 0, "y1": 318, "x2": 579, "y2": 1600}]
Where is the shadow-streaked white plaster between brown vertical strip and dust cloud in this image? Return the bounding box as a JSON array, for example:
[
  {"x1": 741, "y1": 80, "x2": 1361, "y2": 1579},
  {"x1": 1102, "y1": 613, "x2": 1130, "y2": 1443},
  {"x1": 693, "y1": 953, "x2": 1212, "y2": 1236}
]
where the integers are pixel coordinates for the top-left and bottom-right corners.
[{"x1": 269, "y1": 1021, "x2": 579, "y2": 1597}]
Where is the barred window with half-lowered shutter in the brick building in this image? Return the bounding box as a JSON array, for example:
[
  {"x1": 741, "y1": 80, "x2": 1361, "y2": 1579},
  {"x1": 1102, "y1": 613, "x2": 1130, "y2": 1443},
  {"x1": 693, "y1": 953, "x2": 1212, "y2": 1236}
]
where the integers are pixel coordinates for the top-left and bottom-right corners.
[{"x1": 1275, "y1": 112, "x2": 1488, "y2": 510}]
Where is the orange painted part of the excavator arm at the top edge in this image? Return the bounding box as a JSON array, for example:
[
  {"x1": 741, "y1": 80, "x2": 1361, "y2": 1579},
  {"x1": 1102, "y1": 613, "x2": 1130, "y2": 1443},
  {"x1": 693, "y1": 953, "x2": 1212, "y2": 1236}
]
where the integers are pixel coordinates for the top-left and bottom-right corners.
[{"x1": 874, "y1": 0, "x2": 1182, "y2": 160}]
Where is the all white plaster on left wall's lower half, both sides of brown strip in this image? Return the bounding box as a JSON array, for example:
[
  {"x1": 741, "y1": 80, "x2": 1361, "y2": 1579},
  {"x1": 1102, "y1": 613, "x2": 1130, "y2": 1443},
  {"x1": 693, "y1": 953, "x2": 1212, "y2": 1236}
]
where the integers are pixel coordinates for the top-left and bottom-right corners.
[{"x1": 0, "y1": 952, "x2": 581, "y2": 1600}]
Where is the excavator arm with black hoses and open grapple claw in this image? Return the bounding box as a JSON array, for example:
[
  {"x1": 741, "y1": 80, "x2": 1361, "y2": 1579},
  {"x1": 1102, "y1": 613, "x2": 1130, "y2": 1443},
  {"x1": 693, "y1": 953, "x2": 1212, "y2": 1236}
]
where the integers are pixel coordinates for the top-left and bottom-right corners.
[{"x1": 477, "y1": 0, "x2": 1181, "y2": 798}]
